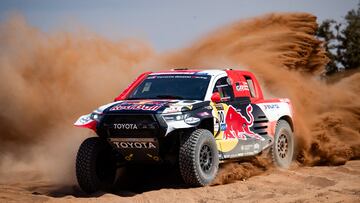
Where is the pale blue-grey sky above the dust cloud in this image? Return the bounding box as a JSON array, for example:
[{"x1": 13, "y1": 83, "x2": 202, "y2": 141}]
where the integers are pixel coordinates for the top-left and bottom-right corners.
[{"x1": 0, "y1": 0, "x2": 359, "y2": 51}]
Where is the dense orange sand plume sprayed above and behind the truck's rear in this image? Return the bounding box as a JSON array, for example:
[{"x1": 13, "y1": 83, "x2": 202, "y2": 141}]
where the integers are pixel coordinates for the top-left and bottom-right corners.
[{"x1": 165, "y1": 13, "x2": 360, "y2": 183}]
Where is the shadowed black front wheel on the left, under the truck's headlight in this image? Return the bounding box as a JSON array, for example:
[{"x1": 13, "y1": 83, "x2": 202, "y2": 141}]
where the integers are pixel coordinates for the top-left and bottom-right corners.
[{"x1": 76, "y1": 137, "x2": 117, "y2": 193}]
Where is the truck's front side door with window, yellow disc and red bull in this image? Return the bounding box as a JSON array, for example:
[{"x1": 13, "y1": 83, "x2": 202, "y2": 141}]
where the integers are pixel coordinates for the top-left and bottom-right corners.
[{"x1": 212, "y1": 77, "x2": 262, "y2": 159}]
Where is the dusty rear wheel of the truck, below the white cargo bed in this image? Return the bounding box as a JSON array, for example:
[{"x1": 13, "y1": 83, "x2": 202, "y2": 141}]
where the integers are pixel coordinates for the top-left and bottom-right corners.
[{"x1": 271, "y1": 120, "x2": 294, "y2": 168}]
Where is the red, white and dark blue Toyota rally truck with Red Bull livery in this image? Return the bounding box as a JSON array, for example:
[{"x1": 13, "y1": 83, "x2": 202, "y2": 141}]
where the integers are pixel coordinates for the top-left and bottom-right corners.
[{"x1": 75, "y1": 69, "x2": 294, "y2": 193}]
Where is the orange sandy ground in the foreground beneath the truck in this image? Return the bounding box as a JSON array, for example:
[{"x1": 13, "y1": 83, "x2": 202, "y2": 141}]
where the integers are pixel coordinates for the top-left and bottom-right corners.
[{"x1": 0, "y1": 160, "x2": 360, "y2": 202}]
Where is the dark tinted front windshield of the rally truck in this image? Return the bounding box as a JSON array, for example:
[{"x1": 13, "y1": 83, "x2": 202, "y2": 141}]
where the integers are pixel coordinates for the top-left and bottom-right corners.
[{"x1": 127, "y1": 74, "x2": 210, "y2": 100}]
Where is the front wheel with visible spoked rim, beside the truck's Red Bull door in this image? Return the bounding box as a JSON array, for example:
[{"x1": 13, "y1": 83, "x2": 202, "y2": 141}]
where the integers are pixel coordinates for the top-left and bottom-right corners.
[{"x1": 179, "y1": 129, "x2": 219, "y2": 186}]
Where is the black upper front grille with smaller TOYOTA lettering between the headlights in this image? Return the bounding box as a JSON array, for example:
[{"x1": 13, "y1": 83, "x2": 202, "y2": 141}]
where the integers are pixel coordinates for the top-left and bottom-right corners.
[{"x1": 98, "y1": 114, "x2": 160, "y2": 138}]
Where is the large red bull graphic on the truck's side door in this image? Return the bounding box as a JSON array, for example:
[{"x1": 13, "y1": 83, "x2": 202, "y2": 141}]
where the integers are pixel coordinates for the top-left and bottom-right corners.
[{"x1": 223, "y1": 104, "x2": 264, "y2": 140}]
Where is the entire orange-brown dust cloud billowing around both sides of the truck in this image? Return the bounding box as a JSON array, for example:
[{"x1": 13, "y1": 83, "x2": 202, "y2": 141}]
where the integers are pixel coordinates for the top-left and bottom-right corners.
[{"x1": 0, "y1": 13, "x2": 360, "y2": 184}]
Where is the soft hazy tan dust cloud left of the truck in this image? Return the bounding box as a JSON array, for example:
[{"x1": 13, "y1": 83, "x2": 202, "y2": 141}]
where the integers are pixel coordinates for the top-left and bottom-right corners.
[{"x1": 0, "y1": 16, "x2": 154, "y2": 185}]
